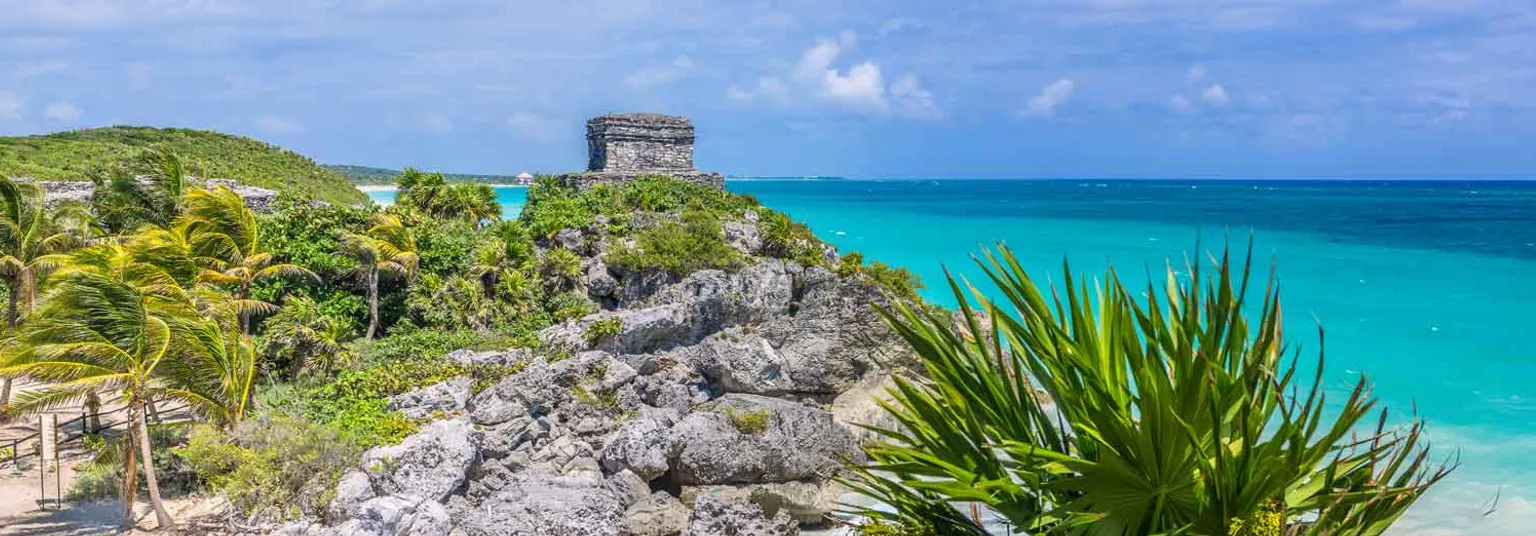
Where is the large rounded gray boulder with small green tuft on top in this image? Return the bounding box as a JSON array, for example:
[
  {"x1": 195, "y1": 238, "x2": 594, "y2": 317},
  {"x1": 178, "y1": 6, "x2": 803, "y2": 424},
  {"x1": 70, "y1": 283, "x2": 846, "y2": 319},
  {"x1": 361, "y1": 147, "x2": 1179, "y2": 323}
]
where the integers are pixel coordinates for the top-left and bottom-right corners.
[{"x1": 668, "y1": 395, "x2": 863, "y2": 485}]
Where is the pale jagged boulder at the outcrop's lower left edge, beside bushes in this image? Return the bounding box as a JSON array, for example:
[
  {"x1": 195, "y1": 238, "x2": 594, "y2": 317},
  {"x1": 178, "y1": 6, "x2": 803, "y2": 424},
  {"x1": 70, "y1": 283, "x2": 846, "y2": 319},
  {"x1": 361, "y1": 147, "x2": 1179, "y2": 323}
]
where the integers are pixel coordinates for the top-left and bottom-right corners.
[{"x1": 362, "y1": 418, "x2": 478, "y2": 502}]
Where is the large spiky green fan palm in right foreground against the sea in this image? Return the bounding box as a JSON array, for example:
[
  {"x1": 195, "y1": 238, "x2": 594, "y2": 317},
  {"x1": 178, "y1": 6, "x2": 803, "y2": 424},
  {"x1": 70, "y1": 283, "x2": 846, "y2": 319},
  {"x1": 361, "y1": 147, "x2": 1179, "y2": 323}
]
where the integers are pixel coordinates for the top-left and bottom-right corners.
[{"x1": 846, "y1": 247, "x2": 1450, "y2": 536}]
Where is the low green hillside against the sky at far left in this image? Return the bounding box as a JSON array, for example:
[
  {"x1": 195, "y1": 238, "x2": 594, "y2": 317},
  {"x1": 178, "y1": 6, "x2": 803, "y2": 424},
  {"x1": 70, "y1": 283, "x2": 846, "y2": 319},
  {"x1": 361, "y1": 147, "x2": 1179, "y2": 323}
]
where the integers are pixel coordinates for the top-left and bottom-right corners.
[{"x1": 0, "y1": 126, "x2": 367, "y2": 203}]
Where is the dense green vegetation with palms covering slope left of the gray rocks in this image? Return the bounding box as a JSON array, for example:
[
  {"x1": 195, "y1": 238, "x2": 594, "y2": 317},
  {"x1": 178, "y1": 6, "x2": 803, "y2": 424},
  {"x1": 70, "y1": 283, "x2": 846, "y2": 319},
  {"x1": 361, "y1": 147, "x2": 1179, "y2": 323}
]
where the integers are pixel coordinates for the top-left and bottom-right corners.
[{"x1": 0, "y1": 159, "x2": 866, "y2": 525}]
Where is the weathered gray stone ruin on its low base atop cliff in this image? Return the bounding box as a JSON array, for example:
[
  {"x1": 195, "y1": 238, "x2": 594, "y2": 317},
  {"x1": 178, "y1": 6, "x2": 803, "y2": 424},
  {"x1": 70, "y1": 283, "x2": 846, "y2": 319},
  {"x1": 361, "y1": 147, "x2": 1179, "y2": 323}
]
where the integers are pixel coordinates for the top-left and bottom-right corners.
[{"x1": 561, "y1": 114, "x2": 725, "y2": 189}]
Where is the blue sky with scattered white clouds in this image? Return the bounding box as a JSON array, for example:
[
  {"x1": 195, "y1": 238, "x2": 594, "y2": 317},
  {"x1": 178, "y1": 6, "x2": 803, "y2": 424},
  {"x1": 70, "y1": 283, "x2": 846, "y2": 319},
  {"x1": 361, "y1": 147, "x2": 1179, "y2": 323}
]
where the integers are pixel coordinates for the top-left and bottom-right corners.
[{"x1": 0, "y1": 0, "x2": 1536, "y2": 178}]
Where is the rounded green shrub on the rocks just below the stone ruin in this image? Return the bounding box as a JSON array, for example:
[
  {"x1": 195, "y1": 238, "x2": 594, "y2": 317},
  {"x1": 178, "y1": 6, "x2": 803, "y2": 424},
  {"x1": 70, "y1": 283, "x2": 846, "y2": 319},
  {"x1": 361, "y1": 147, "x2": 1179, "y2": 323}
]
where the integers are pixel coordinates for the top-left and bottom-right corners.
[{"x1": 608, "y1": 210, "x2": 743, "y2": 278}]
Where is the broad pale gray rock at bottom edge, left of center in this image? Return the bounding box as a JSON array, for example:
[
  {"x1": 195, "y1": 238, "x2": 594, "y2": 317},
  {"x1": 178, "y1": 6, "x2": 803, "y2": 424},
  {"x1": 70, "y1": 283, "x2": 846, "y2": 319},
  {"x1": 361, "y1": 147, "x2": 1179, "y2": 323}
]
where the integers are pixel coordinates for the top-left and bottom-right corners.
[{"x1": 458, "y1": 470, "x2": 624, "y2": 536}]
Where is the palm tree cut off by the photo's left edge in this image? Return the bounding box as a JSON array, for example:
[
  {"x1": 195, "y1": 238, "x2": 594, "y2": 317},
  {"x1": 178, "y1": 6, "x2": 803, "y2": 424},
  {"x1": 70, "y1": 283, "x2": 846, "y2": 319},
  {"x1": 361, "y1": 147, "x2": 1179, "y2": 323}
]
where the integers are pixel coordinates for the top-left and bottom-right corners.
[{"x1": 0, "y1": 175, "x2": 80, "y2": 405}]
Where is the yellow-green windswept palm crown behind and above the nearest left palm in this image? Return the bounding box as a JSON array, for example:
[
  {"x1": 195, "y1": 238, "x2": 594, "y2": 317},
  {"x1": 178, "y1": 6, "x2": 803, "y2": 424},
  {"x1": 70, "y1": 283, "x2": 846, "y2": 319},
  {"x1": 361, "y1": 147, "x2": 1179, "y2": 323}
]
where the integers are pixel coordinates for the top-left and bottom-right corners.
[{"x1": 177, "y1": 186, "x2": 319, "y2": 333}]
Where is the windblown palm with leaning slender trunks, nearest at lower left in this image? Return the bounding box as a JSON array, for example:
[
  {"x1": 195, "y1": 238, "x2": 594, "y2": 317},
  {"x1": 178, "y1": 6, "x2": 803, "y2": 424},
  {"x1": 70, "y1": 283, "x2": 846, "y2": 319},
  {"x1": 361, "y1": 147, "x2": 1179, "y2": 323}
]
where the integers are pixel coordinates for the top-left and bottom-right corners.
[{"x1": 0, "y1": 256, "x2": 198, "y2": 528}]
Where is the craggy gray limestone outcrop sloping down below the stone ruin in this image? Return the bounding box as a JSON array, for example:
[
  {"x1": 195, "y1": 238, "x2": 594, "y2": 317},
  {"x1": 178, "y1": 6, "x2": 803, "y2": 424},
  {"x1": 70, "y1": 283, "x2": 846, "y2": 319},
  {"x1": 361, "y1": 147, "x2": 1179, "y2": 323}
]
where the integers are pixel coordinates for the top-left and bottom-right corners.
[{"x1": 290, "y1": 196, "x2": 912, "y2": 536}]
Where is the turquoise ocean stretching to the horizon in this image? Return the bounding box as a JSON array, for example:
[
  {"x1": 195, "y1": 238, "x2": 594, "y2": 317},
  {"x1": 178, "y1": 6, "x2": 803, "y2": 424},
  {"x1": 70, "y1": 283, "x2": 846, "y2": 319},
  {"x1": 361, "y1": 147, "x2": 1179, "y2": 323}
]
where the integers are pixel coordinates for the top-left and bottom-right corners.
[{"x1": 370, "y1": 180, "x2": 1536, "y2": 534}]
